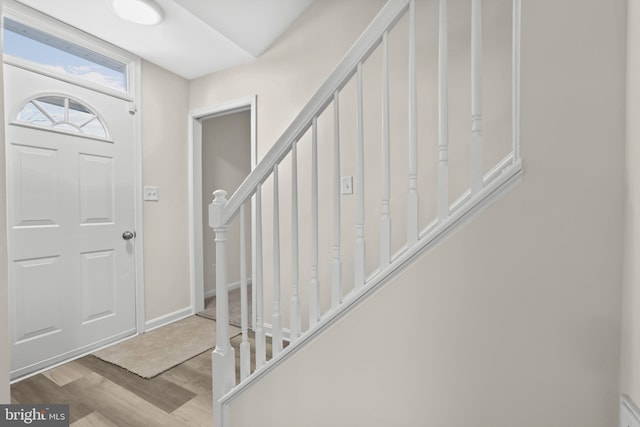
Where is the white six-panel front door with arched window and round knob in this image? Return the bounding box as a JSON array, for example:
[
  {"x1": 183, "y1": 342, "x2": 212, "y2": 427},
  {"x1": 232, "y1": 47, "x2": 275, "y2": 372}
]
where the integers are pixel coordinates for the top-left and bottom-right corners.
[{"x1": 4, "y1": 65, "x2": 136, "y2": 378}]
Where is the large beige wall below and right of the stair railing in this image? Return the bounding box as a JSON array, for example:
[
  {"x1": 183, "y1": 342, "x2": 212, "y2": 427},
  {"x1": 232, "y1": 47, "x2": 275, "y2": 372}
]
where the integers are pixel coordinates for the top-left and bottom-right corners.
[{"x1": 224, "y1": 0, "x2": 626, "y2": 427}]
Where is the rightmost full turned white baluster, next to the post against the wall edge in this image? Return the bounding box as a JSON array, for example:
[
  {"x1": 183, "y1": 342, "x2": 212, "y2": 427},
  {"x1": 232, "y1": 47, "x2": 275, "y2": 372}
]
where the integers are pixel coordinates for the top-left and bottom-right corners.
[{"x1": 471, "y1": 0, "x2": 484, "y2": 194}]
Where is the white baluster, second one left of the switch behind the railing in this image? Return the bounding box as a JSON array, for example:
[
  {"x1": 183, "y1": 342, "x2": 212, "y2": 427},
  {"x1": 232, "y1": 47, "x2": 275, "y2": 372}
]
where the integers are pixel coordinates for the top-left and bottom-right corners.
[{"x1": 309, "y1": 117, "x2": 320, "y2": 327}]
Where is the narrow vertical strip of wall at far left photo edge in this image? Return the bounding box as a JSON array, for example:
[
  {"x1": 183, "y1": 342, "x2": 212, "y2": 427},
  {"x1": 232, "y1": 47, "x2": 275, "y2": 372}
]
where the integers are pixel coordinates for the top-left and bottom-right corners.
[{"x1": 0, "y1": 0, "x2": 10, "y2": 403}]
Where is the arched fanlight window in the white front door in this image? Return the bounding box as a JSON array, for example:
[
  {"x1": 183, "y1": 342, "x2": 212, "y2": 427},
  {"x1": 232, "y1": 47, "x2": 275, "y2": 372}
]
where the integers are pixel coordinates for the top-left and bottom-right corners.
[{"x1": 18, "y1": 95, "x2": 108, "y2": 138}]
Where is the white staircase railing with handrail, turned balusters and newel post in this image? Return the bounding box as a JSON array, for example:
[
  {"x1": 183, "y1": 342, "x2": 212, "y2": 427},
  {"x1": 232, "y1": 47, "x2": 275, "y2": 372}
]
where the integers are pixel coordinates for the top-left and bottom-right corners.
[{"x1": 209, "y1": 0, "x2": 522, "y2": 427}]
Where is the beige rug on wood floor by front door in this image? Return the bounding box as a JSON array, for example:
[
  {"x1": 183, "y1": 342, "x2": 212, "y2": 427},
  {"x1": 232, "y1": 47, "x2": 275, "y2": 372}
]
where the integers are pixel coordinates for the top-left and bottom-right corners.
[{"x1": 94, "y1": 316, "x2": 240, "y2": 378}]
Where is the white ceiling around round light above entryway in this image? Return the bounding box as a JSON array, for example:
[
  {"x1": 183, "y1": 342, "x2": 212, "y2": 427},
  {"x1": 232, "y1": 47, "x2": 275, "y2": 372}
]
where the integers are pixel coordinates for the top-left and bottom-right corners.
[{"x1": 13, "y1": 0, "x2": 313, "y2": 79}]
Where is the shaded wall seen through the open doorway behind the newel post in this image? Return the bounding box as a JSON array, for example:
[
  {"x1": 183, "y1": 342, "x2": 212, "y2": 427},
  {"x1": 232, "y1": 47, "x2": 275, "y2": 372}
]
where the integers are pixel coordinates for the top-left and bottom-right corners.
[{"x1": 202, "y1": 110, "x2": 251, "y2": 293}]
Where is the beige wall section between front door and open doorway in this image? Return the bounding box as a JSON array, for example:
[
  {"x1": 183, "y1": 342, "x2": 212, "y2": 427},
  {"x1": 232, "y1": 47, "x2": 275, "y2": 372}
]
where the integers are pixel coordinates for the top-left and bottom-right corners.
[{"x1": 142, "y1": 61, "x2": 191, "y2": 321}]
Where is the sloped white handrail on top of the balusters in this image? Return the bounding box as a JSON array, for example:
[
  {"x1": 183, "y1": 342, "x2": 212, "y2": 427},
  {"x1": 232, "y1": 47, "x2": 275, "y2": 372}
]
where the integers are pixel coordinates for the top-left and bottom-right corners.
[{"x1": 222, "y1": 0, "x2": 410, "y2": 224}]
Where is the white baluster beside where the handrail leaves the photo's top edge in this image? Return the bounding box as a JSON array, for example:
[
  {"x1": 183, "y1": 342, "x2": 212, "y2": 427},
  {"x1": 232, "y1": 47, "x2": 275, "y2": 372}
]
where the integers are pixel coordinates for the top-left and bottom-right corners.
[{"x1": 407, "y1": 0, "x2": 419, "y2": 247}]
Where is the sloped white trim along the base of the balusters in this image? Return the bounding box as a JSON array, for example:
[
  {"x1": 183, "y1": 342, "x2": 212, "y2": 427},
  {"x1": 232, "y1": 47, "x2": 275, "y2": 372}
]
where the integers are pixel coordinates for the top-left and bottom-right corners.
[{"x1": 214, "y1": 161, "x2": 522, "y2": 416}]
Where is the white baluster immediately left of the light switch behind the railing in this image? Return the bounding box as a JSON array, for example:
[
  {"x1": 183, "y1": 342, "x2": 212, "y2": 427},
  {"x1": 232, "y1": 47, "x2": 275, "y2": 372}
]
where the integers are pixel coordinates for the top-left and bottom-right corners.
[{"x1": 331, "y1": 91, "x2": 342, "y2": 308}]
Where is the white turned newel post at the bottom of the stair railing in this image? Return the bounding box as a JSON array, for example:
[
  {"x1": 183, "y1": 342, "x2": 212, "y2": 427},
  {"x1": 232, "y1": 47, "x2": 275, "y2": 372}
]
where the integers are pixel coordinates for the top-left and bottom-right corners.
[{"x1": 209, "y1": 190, "x2": 236, "y2": 427}]
